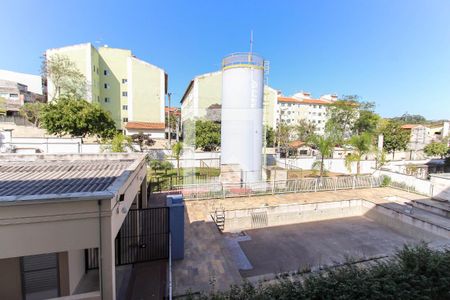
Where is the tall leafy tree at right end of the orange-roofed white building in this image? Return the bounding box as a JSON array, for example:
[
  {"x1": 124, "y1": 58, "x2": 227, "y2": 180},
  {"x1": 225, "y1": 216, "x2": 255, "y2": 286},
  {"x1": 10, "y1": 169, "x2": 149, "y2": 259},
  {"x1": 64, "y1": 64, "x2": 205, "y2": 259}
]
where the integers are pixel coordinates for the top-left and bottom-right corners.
[{"x1": 325, "y1": 96, "x2": 359, "y2": 142}]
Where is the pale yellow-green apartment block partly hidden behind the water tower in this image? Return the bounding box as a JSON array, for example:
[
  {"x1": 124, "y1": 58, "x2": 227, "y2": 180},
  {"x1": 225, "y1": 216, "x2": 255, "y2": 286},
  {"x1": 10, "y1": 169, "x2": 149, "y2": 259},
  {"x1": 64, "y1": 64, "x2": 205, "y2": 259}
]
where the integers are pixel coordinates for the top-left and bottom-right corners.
[{"x1": 181, "y1": 71, "x2": 278, "y2": 128}]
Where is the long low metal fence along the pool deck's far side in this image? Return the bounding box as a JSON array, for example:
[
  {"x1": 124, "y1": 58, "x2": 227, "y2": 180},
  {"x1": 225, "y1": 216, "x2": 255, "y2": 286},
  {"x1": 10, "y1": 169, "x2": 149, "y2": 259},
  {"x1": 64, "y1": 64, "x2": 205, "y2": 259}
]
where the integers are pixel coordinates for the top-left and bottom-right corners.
[{"x1": 172, "y1": 175, "x2": 382, "y2": 200}]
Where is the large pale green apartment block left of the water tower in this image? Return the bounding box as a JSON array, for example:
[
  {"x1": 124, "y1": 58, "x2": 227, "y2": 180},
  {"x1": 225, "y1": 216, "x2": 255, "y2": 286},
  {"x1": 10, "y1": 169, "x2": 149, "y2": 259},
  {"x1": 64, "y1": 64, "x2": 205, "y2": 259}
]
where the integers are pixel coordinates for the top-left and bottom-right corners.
[{"x1": 46, "y1": 43, "x2": 168, "y2": 138}]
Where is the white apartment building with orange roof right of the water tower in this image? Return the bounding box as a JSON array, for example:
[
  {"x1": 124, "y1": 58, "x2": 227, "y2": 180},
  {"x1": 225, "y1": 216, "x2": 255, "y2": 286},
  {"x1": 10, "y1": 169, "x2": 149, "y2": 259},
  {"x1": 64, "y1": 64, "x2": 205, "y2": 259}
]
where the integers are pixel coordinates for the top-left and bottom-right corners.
[{"x1": 276, "y1": 92, "x2": 337, "y2": 134}]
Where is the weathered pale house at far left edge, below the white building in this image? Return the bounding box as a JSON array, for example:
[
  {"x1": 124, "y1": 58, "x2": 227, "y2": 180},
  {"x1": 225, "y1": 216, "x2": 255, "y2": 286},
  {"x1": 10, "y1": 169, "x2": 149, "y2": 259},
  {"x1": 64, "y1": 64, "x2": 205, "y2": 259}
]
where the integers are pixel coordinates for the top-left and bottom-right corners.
[{"x1": 0, "y1": 78, "x2": 44, "y2": 116}]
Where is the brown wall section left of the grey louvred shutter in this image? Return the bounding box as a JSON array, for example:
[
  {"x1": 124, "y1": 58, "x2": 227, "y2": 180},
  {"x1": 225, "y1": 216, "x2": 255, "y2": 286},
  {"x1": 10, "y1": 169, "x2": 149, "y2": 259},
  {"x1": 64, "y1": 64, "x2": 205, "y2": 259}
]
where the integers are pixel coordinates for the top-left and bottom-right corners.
[{"x1": 0, "y1": 257, "x2": 22, "y2": 300}]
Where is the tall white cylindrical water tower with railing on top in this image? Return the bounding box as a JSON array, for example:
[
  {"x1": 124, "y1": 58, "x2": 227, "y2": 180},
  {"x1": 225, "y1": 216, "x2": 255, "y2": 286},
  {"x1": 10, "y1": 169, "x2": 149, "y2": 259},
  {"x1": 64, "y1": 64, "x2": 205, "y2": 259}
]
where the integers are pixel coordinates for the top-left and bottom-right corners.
[{"x1": 221, "y1": 53, "x2": 264, "y2": 182}]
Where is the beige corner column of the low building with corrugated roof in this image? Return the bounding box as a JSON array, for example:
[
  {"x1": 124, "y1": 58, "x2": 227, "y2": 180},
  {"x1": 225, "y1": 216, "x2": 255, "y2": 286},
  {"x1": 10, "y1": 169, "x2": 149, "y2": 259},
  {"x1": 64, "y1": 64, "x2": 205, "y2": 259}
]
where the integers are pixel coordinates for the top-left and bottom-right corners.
[{"x1": 99, "y1": 200, "x2": 116, "y2": 300}]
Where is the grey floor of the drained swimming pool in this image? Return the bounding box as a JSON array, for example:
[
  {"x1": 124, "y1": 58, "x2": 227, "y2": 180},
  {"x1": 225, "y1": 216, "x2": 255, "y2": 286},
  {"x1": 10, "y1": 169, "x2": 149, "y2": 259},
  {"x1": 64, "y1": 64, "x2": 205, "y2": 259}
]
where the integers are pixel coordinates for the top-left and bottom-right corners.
[{"x1": 239, "y1": 217, "x2": 417, "y2": 277}]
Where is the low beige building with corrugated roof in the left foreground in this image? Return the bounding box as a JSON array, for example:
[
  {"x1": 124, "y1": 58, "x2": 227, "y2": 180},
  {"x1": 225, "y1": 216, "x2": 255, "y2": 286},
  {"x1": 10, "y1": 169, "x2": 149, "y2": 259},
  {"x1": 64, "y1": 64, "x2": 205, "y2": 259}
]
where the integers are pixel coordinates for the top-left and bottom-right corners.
[{"x1": 0, "y1": 153, "x2": 147, "y2": 300}]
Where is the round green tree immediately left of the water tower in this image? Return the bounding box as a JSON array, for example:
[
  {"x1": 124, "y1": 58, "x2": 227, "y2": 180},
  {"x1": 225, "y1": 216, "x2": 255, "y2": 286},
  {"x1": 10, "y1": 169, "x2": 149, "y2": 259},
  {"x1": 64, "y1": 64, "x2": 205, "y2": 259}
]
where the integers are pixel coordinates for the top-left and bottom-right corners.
[{"x1": 195, "y1": 120, "x2": 220, "y2": 151}]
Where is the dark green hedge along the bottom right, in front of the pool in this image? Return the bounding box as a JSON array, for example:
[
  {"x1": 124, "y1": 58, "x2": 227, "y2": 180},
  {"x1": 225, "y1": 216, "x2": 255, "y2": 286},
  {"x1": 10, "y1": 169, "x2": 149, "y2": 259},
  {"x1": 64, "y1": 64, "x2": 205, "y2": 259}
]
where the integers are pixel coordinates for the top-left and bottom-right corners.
[{"x1": 188, "y1": 245, "x2": 450, "y2": 300}]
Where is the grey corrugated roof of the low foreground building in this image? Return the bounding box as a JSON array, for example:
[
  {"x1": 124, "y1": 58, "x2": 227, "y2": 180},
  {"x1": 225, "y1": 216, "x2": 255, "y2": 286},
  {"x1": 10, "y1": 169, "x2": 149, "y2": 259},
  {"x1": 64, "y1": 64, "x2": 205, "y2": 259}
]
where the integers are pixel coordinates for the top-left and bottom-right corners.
[{"x1": 0, "y1": 159, "x2": 134, "y2": 201}]
